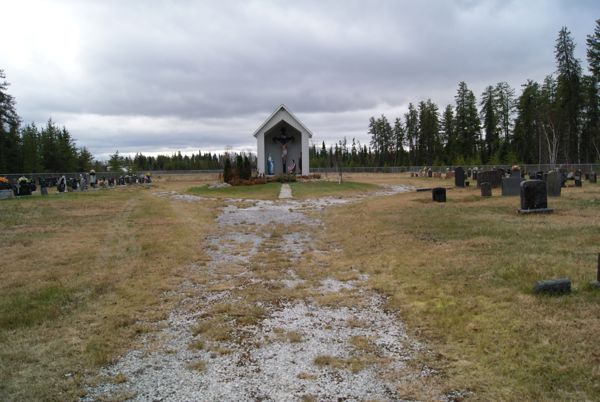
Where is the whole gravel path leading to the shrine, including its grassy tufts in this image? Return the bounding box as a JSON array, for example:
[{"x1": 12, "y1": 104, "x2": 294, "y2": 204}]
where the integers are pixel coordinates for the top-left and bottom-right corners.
[{"x1": 83, "y1": 188, "x2": 446, "y2": 401}]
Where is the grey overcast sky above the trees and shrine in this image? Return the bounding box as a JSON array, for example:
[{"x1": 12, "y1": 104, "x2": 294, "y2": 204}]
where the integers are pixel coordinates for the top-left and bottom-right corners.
[{"x1": 0, "y1": 0, "x2": 600, "y2": 159}]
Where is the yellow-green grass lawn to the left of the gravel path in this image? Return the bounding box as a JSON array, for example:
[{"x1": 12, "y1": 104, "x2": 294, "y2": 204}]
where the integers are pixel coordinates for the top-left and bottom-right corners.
[{"x1": 0, "y1": 187, "x2": 214, "y2": 401}]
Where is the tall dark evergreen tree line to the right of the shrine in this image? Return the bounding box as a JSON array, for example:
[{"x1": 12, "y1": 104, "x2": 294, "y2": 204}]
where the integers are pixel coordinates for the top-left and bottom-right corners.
[{"x1": 310, "y1": 20, "x2": 600, "y2": 167}]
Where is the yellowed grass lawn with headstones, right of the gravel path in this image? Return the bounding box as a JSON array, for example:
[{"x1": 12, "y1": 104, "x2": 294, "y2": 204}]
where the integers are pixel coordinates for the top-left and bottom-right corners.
[{"x1": 326, "y1": 177, "x2": 600, "y2": 401}]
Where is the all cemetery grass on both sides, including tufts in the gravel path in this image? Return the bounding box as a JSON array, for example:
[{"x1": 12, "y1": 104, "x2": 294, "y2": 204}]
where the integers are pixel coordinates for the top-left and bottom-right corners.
[{"x1": 0, "y1": 174, "x2": 600, "y2": 401}]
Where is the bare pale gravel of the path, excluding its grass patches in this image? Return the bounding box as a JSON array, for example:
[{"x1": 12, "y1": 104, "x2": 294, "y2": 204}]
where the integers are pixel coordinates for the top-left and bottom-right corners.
[{"x1": 81, "y1": 186, "x2": 442, "y2": 401}]
